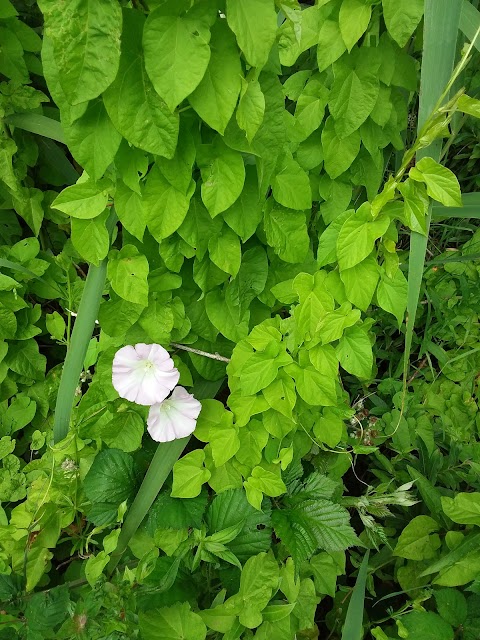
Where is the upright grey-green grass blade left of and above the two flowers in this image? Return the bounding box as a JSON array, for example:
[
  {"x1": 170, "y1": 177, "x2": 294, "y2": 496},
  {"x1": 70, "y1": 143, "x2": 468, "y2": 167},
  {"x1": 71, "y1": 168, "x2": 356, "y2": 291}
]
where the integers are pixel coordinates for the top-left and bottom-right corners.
[{"x1": 53, "y1": 208, "x2": 117, "y2": 443}]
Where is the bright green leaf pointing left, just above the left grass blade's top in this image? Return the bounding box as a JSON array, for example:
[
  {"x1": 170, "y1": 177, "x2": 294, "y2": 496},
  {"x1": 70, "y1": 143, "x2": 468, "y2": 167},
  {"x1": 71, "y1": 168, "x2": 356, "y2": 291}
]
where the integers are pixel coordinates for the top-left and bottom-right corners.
[{"x1": 51, "y1": 180, "x2": 109, "y2": 220}]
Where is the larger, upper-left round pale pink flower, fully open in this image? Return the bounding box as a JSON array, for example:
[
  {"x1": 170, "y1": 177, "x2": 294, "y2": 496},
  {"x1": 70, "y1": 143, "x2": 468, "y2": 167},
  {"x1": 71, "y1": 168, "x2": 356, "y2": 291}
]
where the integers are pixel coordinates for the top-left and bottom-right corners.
[{"x1": 112, "y1": 343, "x2": 180, "y2": 406}]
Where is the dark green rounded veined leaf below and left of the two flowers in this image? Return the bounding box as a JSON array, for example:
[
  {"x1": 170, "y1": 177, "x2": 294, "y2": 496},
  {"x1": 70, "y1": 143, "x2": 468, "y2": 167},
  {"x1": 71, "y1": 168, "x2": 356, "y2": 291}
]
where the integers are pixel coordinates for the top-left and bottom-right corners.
[{"x1": 83, "y1": 449, "x2": 136, "y2": 526}]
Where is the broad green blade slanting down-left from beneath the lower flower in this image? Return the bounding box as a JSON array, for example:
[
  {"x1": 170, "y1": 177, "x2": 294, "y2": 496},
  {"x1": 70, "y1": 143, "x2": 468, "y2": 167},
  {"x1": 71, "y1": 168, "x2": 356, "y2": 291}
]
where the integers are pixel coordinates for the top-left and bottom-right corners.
[{"x1": 107, "y1": 438, "x2": 190, "y2": 574}]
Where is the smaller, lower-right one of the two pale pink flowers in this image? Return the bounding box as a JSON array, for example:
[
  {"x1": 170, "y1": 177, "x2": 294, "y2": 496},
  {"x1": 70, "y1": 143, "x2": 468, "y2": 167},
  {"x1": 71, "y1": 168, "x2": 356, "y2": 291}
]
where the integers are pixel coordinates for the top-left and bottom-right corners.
[{"x1": 147, "y1": 387, "x2": 202, "y2": 442}]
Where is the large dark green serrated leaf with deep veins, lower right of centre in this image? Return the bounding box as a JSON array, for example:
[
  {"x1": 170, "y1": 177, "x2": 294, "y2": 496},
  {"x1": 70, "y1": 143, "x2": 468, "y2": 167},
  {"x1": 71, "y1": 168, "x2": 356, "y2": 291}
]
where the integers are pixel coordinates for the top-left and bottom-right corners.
[{"x1": 272, "y1": 499, "x2": 358, "y2": 567}]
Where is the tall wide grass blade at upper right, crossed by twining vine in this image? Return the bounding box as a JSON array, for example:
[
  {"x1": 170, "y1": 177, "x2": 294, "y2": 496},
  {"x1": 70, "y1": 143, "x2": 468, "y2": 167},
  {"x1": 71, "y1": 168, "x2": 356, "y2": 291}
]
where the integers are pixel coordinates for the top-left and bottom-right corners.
[{"x1": 404, "y1": 0, "x2": 463, "y2": 379}]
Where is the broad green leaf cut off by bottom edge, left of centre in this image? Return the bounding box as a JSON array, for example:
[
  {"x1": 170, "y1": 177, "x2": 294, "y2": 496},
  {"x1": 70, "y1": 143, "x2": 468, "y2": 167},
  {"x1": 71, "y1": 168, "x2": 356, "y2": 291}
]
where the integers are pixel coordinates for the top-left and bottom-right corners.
[{"x1": 139, "y1": 602, "x2": 207, "y2": 640}]
